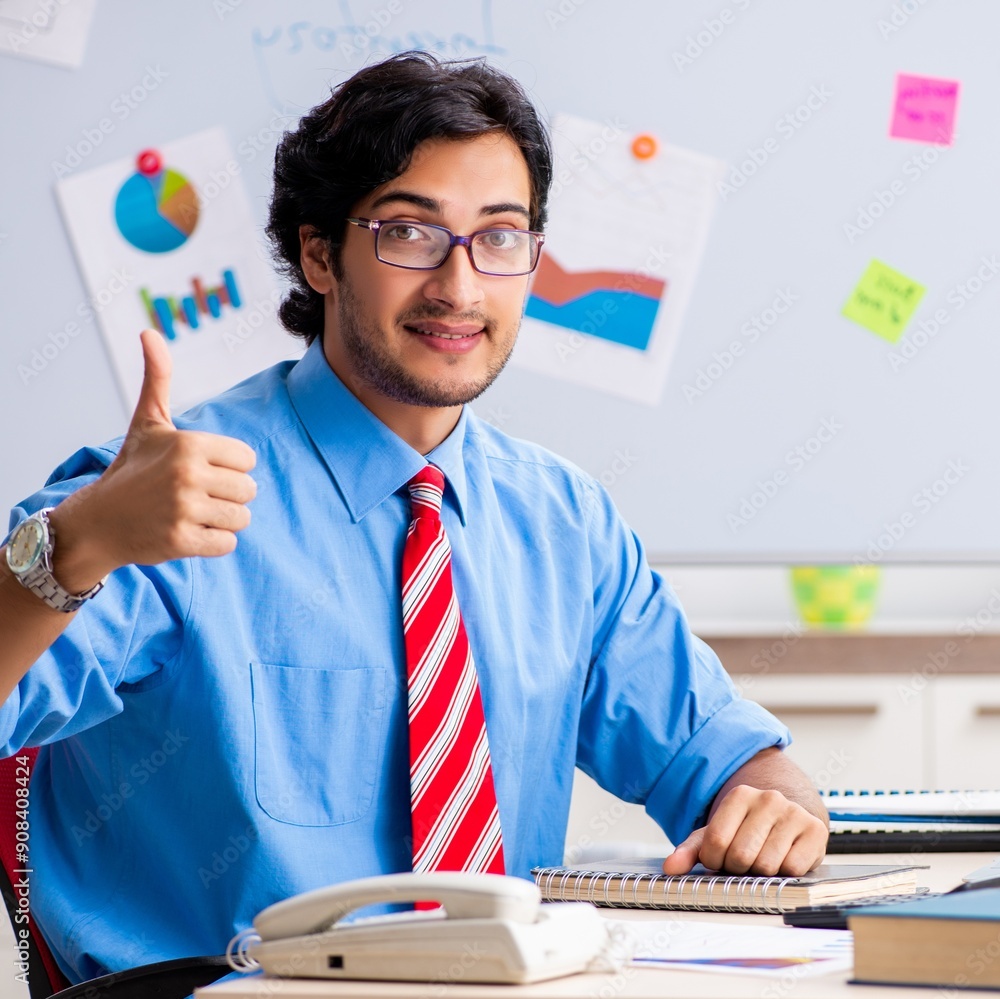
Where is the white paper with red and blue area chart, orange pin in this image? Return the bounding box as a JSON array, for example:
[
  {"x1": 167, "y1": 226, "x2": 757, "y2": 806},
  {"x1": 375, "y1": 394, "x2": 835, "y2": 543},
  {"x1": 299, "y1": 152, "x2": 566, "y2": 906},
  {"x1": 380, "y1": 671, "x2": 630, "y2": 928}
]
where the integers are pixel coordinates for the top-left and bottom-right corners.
[{"x1": 512, "y1": 115, "x2": 724, "y2": 406}]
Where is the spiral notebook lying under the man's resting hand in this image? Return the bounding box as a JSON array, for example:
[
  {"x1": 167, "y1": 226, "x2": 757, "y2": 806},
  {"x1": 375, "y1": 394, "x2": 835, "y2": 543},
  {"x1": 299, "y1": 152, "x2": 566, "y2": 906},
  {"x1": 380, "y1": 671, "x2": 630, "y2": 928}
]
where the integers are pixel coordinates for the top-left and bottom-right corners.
[{"x1": 531, "y1": 858, "x2": 927, "y2": 912}]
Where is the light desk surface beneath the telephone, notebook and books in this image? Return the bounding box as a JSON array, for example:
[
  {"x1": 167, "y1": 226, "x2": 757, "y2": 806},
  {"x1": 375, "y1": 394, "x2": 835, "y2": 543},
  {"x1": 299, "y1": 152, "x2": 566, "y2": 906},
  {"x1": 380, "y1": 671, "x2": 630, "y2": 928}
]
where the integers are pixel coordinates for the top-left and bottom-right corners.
[{"x1": 195, "y1": 853, "x2": 996, "y2": 999}]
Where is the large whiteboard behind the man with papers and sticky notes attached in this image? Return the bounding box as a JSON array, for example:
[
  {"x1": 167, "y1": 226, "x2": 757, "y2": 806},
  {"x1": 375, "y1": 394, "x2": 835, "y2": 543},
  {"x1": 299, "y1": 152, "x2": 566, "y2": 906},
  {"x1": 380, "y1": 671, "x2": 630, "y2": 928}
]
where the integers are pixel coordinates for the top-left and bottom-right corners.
[{"x1": 0, "y1": 0, "x2": 1000, "y2": 562}]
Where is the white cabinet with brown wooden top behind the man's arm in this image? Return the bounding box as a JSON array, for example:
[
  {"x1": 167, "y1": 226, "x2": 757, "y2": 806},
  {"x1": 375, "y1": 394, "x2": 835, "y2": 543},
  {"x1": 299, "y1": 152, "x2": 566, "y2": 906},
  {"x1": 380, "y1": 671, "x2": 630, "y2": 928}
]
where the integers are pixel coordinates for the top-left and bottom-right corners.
[{"x1": 566, "y1": 632, "x2": 1000, "y2": 860}]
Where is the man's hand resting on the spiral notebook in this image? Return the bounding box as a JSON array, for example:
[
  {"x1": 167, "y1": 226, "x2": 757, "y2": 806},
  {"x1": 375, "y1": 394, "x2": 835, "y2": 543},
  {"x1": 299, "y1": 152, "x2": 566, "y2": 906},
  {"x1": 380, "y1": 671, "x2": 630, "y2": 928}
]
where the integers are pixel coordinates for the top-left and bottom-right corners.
[{"x1": 663, "y1": 749, "x2": 829, "y2": 877}]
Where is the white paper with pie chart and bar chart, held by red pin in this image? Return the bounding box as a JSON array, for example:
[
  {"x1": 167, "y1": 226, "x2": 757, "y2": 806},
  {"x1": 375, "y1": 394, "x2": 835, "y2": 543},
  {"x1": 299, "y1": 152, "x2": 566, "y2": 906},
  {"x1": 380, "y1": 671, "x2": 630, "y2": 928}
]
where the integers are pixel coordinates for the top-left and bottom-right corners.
[{"x1": 56, "y1": 128, "x2": 301, "y2": 412}]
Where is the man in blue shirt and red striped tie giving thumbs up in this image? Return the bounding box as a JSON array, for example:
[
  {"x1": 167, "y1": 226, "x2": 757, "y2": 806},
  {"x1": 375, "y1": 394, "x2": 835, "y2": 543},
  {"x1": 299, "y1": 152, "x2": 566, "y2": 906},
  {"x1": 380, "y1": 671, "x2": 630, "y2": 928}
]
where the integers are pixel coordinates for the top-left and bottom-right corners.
[{"x1": 0, "y1": 53, "x2": 827, "y2": 979}]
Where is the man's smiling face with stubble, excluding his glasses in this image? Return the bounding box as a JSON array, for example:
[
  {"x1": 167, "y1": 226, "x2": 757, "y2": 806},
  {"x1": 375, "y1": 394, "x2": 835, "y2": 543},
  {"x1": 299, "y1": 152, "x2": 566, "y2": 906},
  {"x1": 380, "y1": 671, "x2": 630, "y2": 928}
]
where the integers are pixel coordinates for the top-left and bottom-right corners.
[{"x1": 324, "y1": 134, "x2": 531, "y2": 407}]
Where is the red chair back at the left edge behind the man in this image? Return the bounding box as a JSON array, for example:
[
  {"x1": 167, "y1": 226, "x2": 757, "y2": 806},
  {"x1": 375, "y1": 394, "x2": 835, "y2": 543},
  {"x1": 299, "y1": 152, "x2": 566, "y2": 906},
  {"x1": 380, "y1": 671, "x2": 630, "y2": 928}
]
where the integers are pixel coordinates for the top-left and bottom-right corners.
[{"x1": 0, "y1": 749, "x2": 69, "y2": 999}]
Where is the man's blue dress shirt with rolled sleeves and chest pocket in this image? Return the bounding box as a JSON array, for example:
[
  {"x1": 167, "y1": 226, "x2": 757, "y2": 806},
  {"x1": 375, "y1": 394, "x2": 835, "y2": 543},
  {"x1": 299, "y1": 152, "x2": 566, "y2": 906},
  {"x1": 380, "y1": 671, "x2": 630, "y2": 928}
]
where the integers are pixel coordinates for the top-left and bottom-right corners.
[{"x1": 0, "y1": 343, "x2": 788, "y2": 980}]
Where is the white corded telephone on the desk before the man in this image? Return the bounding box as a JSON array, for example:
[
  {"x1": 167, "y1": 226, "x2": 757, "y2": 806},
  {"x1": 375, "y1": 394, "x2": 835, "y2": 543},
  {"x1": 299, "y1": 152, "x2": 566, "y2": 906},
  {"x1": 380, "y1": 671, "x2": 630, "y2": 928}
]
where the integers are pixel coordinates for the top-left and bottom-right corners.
[{"x1": 227, "y1": 872, "x2": 615, "y2": 984}]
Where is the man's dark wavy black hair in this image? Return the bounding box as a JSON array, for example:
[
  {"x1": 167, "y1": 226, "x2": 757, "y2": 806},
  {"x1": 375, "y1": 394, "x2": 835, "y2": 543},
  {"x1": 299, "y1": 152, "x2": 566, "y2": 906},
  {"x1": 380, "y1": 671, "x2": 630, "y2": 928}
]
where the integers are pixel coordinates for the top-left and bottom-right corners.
[{"x1": 267, "y1": 52, "x2": 552, "y2": 343}]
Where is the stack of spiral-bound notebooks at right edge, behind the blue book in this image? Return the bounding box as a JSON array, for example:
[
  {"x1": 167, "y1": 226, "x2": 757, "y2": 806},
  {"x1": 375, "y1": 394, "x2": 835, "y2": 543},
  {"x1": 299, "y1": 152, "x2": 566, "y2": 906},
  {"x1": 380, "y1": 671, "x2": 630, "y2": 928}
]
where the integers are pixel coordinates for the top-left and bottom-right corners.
[{"x1": 822, "y1": 791, "x2": 1000, "y2": 853}]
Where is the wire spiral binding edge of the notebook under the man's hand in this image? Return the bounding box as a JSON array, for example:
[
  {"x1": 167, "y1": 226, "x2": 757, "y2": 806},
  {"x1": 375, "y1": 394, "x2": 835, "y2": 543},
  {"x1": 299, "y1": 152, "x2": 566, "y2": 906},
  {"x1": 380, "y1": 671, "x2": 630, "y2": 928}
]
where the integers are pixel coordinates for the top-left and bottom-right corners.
[{"x1": 536, "y1": 869, "x2": 796, "y2": 914}]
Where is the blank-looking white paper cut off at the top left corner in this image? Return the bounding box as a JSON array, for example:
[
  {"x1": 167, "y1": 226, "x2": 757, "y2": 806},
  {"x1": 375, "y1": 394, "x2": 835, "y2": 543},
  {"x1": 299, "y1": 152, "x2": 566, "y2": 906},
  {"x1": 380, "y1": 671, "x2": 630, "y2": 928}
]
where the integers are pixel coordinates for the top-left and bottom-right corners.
[{"x1": 0, "y1": 0, "x2": 97, "y2": 69}]
